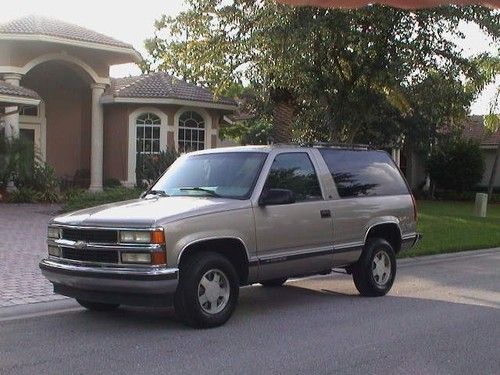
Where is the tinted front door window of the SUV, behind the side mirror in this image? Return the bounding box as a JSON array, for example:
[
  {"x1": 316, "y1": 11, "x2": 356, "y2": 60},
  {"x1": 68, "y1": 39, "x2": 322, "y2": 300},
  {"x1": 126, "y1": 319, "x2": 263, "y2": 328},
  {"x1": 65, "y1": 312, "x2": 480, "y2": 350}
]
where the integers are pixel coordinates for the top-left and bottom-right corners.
[{"x1": 264, "y1": 153, "x2": 323, "y2": 202}]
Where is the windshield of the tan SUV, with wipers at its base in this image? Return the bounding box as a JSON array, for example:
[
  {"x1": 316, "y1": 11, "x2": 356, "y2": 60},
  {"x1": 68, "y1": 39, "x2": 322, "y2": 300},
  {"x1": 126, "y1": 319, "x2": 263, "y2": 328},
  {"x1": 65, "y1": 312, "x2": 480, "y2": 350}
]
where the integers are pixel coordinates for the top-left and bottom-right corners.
[{"x1": 151, "y1": 152, "x2": 267, "y2": 199}]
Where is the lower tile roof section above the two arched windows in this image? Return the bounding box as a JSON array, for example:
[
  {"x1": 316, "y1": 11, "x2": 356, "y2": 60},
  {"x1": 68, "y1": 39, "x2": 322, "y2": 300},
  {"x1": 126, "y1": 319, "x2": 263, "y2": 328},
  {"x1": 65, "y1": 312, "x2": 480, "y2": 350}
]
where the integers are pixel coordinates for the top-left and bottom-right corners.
[{"x1": 106, "y1": 72, "x2": 237, "y2": 107}]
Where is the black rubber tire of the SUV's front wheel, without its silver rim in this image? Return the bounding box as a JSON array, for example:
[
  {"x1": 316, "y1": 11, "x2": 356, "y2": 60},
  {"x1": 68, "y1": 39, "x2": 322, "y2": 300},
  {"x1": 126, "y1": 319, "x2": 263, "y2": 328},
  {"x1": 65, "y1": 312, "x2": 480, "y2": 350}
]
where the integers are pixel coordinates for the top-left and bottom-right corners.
[{"x1": 174, "y1": 251, "x2": 239, "y2": 328}]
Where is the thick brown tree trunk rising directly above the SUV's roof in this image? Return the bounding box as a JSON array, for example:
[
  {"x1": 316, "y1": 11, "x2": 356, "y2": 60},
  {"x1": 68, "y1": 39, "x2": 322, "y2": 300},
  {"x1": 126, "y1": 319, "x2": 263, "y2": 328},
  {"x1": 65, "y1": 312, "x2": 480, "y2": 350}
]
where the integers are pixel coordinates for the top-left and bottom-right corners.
[{"x1": 272, "y1": 89, "x2": 295, "y2": 143}]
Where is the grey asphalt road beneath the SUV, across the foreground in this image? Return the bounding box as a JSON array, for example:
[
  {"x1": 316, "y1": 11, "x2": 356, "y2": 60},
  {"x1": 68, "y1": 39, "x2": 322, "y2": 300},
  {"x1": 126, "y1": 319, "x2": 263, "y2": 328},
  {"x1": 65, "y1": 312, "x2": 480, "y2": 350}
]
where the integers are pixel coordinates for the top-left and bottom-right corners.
[{"x1": 0, "y1": 250, "x2": 500, "y2": 375}]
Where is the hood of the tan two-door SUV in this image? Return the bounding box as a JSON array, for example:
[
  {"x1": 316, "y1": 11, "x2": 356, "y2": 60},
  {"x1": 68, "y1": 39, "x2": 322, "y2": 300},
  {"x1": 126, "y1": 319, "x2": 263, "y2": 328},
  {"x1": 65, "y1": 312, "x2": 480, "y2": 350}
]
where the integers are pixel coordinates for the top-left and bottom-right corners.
[{"x1": 52, "y1": 196, "x2": 250, "y2": 228}]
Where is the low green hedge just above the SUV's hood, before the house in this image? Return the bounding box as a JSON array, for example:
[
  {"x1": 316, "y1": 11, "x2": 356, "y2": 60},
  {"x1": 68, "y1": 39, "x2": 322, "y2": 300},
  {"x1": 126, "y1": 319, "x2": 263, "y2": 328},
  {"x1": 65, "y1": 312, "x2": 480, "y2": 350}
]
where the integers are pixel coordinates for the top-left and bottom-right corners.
[{"x1": 63, "y1": 186, "x2": 141, "y2": 212}]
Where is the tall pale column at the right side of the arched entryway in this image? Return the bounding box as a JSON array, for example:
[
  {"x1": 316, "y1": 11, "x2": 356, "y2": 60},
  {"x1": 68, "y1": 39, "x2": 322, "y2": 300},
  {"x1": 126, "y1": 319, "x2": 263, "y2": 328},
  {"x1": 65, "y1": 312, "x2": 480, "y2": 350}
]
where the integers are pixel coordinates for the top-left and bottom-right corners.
[{"x1": 89, "y1": 83, "x2": 106, "y2": 192}]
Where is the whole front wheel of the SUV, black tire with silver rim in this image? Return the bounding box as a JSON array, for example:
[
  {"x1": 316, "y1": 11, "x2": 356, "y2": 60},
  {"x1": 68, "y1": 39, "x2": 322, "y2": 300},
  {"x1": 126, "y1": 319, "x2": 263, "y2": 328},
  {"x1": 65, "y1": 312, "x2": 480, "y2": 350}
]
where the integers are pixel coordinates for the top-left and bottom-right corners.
[{"x1": 174, "y1": 252, "x2": 239, "y2": 328}]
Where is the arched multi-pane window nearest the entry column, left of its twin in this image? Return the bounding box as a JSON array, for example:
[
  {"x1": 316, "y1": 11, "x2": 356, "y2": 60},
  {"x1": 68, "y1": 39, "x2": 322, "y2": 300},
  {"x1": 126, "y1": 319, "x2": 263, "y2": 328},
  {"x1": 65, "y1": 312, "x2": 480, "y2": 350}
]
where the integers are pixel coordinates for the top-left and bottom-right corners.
[{"x1": 135, "y1": 113, "x2": 161, "y2": 156}]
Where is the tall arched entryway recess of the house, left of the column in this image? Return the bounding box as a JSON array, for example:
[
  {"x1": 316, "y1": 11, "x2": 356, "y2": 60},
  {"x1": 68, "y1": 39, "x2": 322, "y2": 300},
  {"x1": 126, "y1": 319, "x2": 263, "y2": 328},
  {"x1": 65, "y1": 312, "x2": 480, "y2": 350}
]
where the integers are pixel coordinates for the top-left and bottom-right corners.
[{"x1": 19, "y1": 60, "x2": 101, "y2": 188}]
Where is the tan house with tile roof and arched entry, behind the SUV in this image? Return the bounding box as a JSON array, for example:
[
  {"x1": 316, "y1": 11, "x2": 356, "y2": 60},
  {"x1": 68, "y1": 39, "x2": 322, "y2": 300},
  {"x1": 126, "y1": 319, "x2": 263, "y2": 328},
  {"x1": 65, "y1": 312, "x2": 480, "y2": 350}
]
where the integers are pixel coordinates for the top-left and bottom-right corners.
[{"x1": 0, "y1": 16, "x2": 237, "y2": 191}]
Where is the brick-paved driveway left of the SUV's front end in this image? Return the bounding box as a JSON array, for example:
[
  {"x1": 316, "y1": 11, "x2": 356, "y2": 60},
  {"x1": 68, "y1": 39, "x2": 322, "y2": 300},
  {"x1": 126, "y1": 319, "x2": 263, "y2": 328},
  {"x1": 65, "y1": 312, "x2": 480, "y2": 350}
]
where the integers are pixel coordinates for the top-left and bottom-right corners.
[{"x1": 0, "y1": 204, "x2": 64, "y2": 308}]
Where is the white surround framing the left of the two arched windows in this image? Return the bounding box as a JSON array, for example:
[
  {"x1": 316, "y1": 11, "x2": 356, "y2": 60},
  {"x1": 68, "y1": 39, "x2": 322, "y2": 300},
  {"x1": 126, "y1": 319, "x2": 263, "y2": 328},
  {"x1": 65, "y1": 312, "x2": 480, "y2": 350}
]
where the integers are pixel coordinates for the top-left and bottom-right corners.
[{"x1": 126, "y1": 107, "x2": 168, "y2": 187}]
